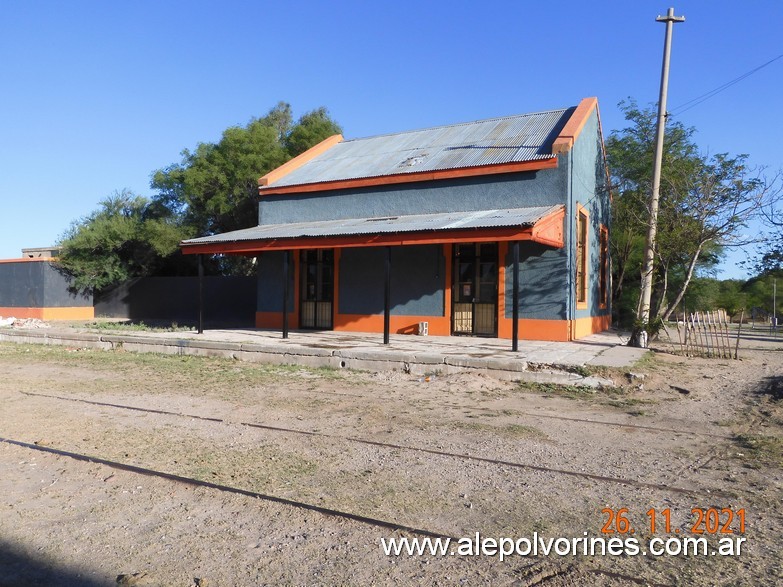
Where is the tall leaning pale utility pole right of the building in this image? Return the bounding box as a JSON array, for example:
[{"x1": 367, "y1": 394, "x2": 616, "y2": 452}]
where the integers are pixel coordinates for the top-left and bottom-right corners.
[{"x1": 631, "y1": 8, "x2": 685, "y2": 348}]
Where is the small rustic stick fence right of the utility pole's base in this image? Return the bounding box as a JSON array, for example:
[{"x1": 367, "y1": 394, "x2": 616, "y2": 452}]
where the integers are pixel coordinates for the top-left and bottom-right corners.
[{"x1": 677, "y1": 310, "x2": 745, "y2": 359}]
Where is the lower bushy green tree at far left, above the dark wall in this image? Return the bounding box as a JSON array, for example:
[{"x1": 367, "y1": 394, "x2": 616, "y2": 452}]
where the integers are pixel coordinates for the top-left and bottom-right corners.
[{"x1": 58, "y1": 190, "x2": 193, "y2": 291}]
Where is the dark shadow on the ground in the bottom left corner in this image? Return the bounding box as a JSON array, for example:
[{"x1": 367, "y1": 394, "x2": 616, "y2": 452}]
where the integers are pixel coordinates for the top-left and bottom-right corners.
[{"x1": 0, "y1": 540, "x2": 107, "y2": 587}]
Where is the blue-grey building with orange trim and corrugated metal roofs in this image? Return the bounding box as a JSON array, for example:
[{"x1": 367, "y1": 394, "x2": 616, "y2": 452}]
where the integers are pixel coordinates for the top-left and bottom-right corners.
[{"x1": 182, "y1": 98, "x2": 611, "y2": 341}]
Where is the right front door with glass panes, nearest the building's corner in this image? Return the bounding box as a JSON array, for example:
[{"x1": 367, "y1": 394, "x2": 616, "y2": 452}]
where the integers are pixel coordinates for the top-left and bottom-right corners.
[{"x1": 451, "y1": 243, "x2": 498, "y2": 336}]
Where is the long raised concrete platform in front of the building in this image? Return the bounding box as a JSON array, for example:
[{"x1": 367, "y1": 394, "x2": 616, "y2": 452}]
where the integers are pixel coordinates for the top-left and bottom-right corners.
[{"x1": 0, "y1": 327, "x2": 647, "y2": 387}]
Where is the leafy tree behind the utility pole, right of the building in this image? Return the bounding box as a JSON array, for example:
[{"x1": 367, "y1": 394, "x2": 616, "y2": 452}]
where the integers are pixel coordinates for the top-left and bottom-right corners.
[{"x1": 607, "y1": 101, "x2": 779, "y2": 319}]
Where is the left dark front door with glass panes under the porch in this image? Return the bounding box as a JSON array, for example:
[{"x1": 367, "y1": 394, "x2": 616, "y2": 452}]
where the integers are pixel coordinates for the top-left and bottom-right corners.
[{"x1": 299, "y1": 249, "x2": 334, "y2": 330}]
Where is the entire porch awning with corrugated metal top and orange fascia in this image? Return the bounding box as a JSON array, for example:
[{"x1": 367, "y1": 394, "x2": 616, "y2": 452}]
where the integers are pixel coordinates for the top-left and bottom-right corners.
[{"x1": 181, "y1": 206, "x2": 564, "y2": 254}]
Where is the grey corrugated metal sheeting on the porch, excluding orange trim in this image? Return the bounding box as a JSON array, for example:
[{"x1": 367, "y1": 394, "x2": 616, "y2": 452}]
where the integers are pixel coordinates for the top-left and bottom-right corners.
[{"x1": 182, "y1": 206, "x2": 562, "y2": 246}]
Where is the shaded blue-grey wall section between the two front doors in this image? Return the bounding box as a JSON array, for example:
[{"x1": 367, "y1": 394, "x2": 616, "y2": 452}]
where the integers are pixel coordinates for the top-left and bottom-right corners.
[{"x1": 338, "y1": 245, "x2": 446, "y2": 316}]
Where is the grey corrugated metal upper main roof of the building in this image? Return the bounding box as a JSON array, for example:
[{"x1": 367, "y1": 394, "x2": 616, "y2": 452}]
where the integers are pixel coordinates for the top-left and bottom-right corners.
[{"x1": 261, "y1": 108, "x2": 573, "y2": 191}]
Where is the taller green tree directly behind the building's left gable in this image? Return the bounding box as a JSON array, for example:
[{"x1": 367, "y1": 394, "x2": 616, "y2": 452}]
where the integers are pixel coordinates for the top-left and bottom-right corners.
[{"x1": 151, "y1": 102, "x2": 341, "y2": 271}]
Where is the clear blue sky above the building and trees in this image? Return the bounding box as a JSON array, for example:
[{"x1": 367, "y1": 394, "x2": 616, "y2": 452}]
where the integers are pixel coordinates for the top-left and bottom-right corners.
[{"x1": 0, "y1": 0, "x2": 783, "y2": 277}]
